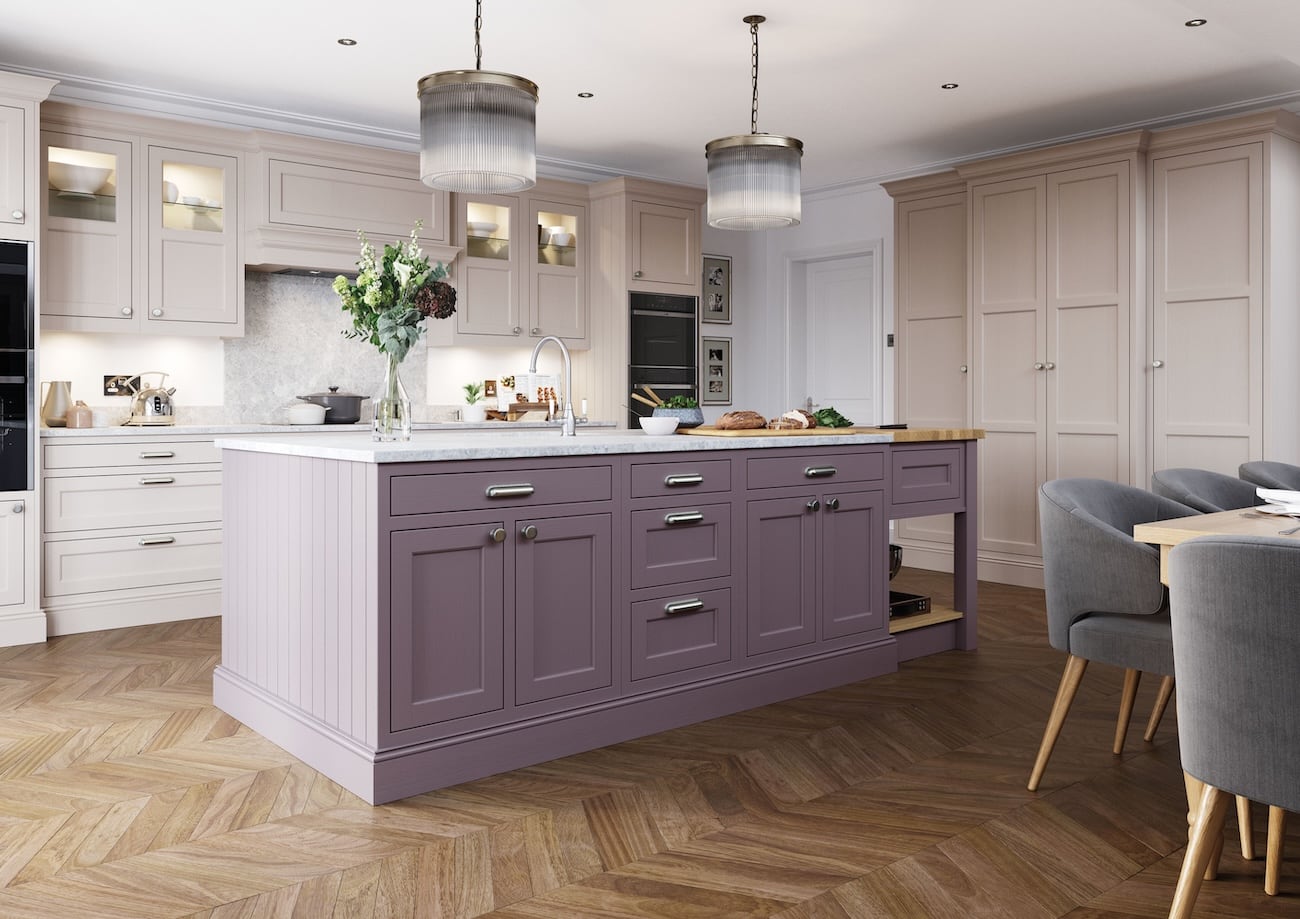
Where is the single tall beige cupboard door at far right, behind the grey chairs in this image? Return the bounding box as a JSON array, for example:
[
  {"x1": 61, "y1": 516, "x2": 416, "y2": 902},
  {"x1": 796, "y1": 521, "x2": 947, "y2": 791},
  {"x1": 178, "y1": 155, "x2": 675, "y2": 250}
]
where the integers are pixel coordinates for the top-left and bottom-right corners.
[{"x1": 1148, "y1": 143, "x2": 1263, "y2": 474}]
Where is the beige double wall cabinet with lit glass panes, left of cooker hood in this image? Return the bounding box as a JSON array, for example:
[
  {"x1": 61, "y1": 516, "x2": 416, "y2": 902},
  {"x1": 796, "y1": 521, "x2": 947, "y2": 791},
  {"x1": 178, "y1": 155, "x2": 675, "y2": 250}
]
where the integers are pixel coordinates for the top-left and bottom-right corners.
[{"x1": 40, "y1": 105, "x2": 243, "y2": 337}]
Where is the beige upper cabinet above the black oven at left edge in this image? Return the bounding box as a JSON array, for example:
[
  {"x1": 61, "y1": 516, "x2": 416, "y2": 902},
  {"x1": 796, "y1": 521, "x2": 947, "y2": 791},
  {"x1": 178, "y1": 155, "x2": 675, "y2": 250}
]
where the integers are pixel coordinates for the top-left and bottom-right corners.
[{"x1": 0, "y1": 73, "x2": 55, "y2": 240}]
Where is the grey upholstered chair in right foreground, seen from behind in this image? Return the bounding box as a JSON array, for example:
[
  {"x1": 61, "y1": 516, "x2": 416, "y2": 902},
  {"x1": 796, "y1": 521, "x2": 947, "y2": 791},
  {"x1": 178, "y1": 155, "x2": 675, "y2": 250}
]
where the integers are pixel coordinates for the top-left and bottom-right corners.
[{"x1": 1169, "y1": 536, "x2": 1300, "y2": 918}]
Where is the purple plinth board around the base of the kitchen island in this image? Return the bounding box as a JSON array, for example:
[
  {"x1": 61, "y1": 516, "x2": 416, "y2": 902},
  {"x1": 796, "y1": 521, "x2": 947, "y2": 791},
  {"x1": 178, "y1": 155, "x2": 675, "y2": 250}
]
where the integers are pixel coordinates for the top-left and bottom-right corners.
[{"x1": 212, "y1": 638, "x2": 898, "y2": 805}]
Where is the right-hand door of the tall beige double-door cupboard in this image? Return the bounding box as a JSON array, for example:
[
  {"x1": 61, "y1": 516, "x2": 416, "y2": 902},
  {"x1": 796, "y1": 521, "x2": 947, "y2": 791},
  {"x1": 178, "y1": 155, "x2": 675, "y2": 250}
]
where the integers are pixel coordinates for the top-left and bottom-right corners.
[{"x1": 1043, "y1": 162, "x2": 1131, "y2": 482}]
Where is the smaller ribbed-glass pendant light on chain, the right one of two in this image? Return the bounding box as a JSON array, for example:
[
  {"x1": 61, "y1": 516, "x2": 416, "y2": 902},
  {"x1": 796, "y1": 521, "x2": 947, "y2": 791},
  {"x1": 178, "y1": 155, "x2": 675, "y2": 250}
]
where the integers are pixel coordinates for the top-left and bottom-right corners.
[{"x1": 705, "y1": 16, "x2": 803, "y2": 230}]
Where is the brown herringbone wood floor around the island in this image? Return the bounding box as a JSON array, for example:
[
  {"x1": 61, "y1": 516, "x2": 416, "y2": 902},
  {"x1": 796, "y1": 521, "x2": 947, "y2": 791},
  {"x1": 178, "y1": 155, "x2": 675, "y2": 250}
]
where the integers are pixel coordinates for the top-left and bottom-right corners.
[{"x1": 0, "y1": 572, "x2": 1300, "y2": 919}]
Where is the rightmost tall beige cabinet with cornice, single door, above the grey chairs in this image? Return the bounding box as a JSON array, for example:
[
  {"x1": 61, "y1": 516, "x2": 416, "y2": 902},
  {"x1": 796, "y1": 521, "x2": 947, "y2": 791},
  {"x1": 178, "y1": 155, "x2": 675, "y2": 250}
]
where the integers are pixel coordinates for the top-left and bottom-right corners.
[{"x1": 1144, "y1": 112, "x2": 1300, "y2": 474}]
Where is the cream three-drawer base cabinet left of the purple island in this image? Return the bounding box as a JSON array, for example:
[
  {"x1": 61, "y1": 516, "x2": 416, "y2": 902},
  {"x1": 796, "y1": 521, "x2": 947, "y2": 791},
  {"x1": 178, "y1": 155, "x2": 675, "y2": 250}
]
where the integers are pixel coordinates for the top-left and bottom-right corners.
[{"x1": 42, "y1": 434, "x2": 221, "y2": 634}]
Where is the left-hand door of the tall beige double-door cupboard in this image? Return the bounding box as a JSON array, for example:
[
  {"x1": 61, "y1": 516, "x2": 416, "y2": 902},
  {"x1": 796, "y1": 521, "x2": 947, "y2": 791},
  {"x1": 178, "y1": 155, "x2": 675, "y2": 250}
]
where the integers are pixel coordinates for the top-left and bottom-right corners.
[{"x1": 971, "y1": 175, "x2": 1047, "y2": 555}]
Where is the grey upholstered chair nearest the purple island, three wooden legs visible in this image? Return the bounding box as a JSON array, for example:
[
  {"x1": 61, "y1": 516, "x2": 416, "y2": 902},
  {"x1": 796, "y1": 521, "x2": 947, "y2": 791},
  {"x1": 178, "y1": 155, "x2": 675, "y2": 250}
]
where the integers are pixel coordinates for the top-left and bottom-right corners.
[{"x1": 1028, "y1": 478, "x2": 1195, "y2": 792}]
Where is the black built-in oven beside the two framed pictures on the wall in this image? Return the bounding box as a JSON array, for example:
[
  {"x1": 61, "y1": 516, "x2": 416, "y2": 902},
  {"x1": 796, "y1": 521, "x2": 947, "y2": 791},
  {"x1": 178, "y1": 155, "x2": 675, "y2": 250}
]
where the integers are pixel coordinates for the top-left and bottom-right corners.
[{"x1": 628, "y1": 291, "x2": 699, "y2": 428}]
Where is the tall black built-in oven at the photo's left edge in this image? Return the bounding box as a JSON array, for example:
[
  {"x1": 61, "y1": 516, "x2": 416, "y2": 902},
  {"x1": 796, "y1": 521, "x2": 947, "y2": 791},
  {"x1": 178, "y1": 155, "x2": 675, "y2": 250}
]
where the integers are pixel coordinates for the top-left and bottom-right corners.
[{"x1": 0, "y1": 240, "x2": 36, "y2": 491}]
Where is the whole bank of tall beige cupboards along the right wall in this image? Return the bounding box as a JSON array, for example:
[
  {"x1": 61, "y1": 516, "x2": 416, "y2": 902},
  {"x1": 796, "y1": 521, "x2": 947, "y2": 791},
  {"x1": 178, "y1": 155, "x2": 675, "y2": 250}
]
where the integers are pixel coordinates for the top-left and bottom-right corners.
[{"x1": 887, "y1": 112, "x2": 1300, "y2": 584}]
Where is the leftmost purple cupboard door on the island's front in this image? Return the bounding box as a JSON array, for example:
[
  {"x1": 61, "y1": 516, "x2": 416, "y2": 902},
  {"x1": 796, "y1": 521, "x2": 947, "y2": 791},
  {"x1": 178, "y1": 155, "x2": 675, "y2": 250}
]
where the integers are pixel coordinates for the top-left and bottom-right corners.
[{"x1": 389, "y1": 524, "x2": 506, "y2": 731}]
